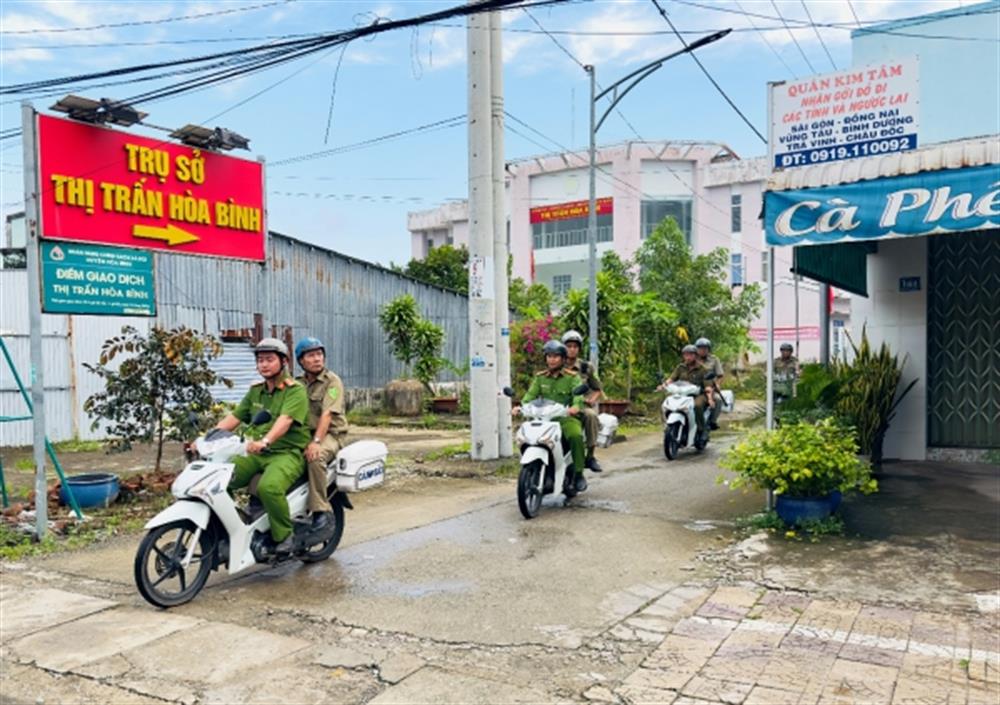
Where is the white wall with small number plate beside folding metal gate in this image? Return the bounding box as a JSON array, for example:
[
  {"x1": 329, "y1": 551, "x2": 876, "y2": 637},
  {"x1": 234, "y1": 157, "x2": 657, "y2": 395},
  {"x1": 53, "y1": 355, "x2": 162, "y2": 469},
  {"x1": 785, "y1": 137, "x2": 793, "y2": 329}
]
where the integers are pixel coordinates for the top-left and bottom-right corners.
[{"x1": 851, "y1": 237, "x2": 927, "y2": 460}]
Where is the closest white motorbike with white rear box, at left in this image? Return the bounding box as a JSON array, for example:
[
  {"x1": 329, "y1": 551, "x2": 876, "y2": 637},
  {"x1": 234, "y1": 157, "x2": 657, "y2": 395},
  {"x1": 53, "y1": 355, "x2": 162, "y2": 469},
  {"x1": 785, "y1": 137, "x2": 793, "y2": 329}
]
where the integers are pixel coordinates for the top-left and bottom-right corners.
[{"x1": 134, "y1": 411, "x2": 388, "y2": 608}]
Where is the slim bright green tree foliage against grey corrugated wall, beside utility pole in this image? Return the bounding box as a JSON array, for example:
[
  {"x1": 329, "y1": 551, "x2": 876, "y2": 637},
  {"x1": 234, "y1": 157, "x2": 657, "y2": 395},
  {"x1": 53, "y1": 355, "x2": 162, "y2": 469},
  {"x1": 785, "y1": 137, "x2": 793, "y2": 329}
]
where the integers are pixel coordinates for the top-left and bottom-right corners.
[{"x1": 379, "y1": 294, "x2": 448, "y2": 391}]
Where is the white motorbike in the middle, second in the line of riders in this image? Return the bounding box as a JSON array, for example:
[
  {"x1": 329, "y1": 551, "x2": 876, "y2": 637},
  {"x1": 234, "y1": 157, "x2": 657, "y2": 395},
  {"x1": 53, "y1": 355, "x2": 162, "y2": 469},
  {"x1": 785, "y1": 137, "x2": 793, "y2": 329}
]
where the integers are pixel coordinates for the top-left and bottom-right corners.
[{"x1": 504, "y1": 385, "x2": 587, "y2": 519}]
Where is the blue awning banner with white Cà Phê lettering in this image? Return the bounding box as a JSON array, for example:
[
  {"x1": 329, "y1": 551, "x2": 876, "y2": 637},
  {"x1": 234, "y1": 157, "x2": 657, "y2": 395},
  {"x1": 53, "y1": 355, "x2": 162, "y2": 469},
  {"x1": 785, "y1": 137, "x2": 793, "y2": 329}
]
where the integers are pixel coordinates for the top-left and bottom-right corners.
[{"x1": 764, "y1": 164, "x2": 1000, "y2": 245}]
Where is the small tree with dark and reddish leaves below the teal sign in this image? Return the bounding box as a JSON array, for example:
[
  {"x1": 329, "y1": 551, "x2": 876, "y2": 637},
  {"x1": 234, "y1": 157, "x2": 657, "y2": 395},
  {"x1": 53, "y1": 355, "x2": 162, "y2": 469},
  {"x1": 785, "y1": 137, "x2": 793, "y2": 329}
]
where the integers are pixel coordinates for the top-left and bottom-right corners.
[{"x1": 83, "y1": 326, "x2": 233, "y2": 471}]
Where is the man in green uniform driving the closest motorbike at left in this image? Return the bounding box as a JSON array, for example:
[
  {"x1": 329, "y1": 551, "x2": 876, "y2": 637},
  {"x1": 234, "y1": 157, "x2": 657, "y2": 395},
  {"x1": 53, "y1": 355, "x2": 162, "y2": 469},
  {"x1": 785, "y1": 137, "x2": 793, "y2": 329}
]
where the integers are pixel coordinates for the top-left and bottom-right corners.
[{"x1": 210, "y1": 338, "x2": 309, "y2": 553}]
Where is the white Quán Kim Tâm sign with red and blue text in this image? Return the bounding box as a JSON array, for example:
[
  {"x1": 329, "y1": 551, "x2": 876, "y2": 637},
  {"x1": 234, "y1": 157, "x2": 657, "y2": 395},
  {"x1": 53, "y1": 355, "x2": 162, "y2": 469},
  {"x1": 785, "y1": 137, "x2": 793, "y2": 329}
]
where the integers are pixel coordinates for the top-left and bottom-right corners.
[{"x1": 770, "y1": 57, "x2": 920, "y2": 169}]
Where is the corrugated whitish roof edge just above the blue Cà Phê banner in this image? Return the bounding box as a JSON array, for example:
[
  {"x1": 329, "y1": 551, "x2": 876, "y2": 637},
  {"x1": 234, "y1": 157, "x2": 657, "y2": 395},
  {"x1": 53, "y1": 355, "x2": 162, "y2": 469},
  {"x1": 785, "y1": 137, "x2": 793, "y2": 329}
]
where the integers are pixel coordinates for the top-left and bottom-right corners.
[{"x1": 765, "y1": 135, "x2": 1000, "y2": 191}]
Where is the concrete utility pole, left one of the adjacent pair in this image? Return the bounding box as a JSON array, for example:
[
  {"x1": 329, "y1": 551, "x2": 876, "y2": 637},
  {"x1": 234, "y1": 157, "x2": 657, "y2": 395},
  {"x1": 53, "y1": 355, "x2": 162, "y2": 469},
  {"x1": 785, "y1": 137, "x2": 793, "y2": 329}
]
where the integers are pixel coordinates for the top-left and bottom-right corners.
[{"x1": 467, "y1": 14, "x2": 500, "y2": 460}]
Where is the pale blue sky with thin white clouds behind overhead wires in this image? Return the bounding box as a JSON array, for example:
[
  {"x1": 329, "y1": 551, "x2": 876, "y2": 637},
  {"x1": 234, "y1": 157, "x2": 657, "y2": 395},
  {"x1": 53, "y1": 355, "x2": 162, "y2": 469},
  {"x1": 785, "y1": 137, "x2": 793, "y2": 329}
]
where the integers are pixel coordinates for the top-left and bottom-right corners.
[{"x1": 0, "y1": 0, "x2": 972, "y2": 264}]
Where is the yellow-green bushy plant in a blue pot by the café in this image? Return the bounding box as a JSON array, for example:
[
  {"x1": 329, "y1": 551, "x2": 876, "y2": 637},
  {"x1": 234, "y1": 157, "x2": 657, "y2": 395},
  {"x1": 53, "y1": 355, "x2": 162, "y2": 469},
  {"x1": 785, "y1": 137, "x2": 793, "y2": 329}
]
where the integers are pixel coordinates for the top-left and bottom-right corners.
[{"x1": 720, "y1": 419, "x2": 878, "y2": 524}]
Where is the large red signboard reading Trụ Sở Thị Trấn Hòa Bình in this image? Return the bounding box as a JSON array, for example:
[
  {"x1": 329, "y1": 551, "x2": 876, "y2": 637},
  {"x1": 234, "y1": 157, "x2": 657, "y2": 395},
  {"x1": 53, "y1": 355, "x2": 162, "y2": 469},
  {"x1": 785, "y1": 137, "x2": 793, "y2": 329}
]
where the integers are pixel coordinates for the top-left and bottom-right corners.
[{"x1": 38, "y1": 115, "x2": 265, "y2": 261}]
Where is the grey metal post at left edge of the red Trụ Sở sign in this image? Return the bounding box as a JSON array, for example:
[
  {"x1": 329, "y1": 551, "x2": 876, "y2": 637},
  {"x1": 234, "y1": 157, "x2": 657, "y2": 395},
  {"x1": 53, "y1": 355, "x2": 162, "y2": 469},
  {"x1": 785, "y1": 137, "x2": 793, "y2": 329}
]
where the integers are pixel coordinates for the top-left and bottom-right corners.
[{"x1": 21, "y1": 101, "x2": 49, "y2": 540}]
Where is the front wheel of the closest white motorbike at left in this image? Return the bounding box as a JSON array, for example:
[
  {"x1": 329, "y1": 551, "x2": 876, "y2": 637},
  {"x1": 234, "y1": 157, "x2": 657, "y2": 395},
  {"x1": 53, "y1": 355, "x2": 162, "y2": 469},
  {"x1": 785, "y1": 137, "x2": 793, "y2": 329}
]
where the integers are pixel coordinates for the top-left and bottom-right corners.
[{"x1": 135, "y1": 519, "x2": 215, "y2": 608}]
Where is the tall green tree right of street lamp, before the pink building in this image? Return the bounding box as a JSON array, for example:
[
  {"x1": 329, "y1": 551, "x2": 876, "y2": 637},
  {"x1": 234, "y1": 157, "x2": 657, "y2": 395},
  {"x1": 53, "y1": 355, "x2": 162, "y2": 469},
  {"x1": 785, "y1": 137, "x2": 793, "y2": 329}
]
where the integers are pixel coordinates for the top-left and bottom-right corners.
[{"x1": 635, "y1": 218, "x2": 764, "y2": 360}]
